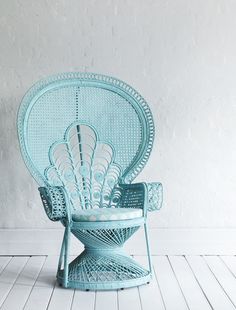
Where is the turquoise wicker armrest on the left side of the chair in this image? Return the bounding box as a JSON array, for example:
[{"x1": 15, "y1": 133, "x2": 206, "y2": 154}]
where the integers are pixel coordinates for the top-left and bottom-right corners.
[{"x1": 38, "y1": 186, "x2": 70, "y2": 221}]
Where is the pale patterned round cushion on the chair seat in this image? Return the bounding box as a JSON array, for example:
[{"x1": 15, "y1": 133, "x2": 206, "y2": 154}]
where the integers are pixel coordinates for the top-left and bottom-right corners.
[{"x1": 72, "y1": 208, "x2": 143, "y2": 222}]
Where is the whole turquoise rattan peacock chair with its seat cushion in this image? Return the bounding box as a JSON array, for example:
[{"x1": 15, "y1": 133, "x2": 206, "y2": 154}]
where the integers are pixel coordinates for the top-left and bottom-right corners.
[{"x1": 18, "y1": 73, "x2": 162, "y2": 290}]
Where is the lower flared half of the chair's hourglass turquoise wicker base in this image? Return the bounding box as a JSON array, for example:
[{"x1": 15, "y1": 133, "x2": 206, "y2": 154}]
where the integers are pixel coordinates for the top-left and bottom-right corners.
[{"x1": 57, "y1": 248, "x2": 151, "y2": 290}]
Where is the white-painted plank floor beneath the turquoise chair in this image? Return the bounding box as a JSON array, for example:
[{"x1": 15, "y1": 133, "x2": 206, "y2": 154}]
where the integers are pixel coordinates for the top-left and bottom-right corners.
[{"x1": 0, "y1": 256, "x2": 236, "y2": 310}]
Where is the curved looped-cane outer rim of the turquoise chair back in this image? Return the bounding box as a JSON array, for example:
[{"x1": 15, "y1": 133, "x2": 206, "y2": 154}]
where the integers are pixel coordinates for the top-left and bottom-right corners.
[{"x1": 17, "y1": 72, "x2": 155, "y2": 186}]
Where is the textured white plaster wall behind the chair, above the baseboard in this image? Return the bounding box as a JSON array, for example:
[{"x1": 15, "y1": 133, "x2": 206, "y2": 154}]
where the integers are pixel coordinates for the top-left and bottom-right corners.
[{"x1": 0, "y1": 0, "x2": 236, "y2": 228}]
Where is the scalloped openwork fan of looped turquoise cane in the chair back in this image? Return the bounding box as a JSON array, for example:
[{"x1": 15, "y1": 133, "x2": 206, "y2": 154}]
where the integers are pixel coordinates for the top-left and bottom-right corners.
[{"x1": 44, "y1": 122, "x2": 122, "y2": 210}]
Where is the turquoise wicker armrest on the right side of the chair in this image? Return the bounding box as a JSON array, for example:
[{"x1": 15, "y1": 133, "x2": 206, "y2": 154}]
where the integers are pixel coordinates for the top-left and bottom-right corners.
[{"x1": 118, "y1": 182, "x2": 162, "y2": 214}]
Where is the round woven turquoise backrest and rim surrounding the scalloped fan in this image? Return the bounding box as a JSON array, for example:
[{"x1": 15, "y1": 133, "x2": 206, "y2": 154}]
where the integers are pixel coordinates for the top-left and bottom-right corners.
[{"x1": 18, "y1": 73, "x2": 154, "y2": 186}]
